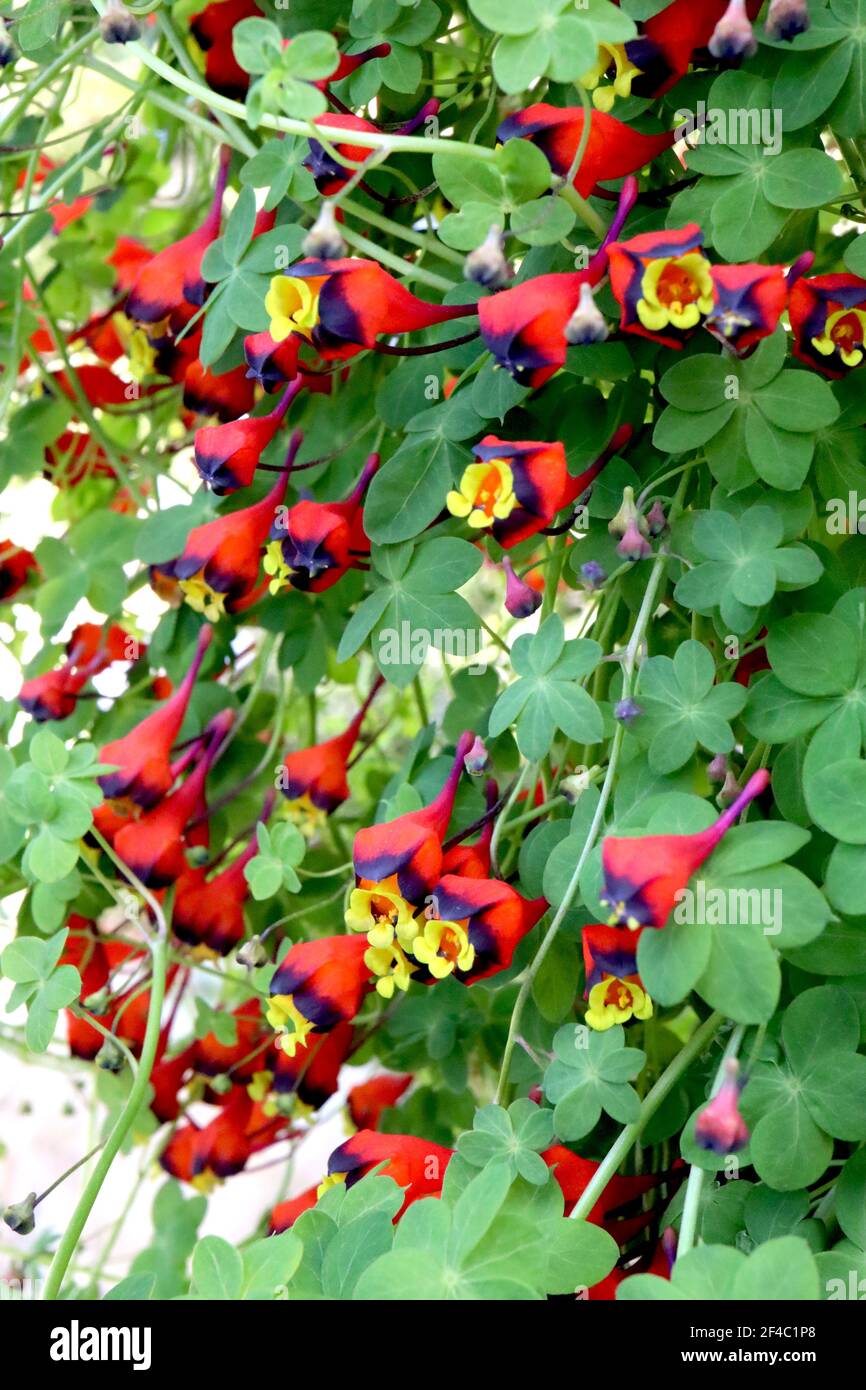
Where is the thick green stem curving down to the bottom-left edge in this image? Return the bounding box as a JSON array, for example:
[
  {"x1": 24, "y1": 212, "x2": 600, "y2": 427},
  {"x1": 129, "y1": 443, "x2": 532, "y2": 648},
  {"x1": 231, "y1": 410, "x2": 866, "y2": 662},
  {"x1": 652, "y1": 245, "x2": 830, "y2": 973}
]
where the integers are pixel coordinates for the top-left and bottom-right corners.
[{"x1": 42, "y1": 934, "x2": 168, "y2": 1302}]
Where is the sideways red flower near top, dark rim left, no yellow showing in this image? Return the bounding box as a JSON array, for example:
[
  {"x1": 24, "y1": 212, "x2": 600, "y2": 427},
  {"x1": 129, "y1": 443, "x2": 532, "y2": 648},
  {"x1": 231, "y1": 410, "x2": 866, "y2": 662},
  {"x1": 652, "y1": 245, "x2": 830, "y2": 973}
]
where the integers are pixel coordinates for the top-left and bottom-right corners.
[{"x1": 496, "y1": 101, "x2": 677, "y2": 197}]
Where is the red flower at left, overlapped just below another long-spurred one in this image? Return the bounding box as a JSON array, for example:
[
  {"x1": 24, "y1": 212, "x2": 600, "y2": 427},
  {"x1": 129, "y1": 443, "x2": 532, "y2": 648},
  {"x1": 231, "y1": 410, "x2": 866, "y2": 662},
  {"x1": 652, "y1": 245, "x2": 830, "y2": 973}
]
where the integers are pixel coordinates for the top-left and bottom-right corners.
[{"x1": 114, "y1": 710, "x2": 234, "y2": 888}]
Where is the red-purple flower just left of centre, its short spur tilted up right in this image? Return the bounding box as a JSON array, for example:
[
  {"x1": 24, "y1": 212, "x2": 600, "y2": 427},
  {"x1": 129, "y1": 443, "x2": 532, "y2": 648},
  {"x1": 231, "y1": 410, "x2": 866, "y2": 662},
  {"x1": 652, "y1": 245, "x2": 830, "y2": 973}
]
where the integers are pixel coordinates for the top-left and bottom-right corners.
[{"x1": 264, "y1": 453, "x2": 379, "y2": 594}]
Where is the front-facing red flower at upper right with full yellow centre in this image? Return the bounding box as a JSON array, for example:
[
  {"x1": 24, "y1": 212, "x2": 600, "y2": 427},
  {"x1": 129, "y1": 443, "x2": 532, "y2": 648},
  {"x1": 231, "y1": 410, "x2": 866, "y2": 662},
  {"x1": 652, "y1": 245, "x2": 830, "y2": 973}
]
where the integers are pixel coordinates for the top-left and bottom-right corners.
[{"x1": 609, "y1": 222, "x2": 713, "y2": 348}]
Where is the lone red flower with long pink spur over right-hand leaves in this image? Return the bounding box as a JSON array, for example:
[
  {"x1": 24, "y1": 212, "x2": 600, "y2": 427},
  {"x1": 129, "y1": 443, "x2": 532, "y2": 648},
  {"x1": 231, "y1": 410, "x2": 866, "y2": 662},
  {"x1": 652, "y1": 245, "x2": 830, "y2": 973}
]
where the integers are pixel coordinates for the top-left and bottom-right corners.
[{"x1": 601, "y1": 767, "x2": 770, "y2": 931}]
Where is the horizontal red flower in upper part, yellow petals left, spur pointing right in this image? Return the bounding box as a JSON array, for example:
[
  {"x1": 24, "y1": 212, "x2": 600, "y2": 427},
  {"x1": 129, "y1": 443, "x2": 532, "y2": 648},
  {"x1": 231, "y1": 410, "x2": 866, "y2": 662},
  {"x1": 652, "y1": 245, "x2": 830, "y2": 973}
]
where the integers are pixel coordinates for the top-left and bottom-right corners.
[{"x1": 264, "y1": 256, "x2": 475, "y2": 359}]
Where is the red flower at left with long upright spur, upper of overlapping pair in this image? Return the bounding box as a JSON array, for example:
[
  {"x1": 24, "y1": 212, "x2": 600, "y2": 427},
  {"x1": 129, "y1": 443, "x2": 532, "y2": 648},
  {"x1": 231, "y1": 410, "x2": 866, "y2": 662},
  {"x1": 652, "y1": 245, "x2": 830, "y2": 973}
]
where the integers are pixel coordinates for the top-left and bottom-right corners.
[{"x1": 99, "y1": 627, "x2": 211, "y2": 808}]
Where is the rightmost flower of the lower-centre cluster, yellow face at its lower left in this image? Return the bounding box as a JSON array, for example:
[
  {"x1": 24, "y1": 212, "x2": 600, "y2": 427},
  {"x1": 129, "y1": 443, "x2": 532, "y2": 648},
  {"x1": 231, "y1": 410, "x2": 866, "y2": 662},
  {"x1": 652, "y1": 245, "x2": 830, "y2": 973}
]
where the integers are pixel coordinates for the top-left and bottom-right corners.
[{"x1": 419, "y1": 874, "x2": 548, "y2": 984}]
